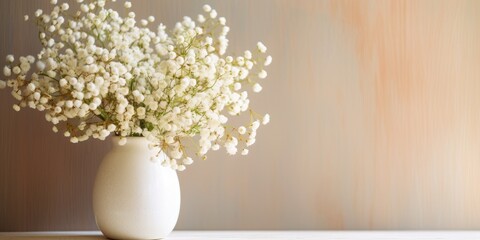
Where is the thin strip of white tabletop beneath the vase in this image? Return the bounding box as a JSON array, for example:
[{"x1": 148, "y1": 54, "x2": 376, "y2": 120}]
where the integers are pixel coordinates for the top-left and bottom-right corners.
[{"x1": 0, "y1": 231, "x2": 480, "y2": 240}]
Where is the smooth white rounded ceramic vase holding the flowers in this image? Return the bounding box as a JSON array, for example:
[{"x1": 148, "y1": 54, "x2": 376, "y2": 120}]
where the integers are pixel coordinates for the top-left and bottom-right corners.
[{"x1": 93, "y1": 137, "x2": 180, "y2": 239}]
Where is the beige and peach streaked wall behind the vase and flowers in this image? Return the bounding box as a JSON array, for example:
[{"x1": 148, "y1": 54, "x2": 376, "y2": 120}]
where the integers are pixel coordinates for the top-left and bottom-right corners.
[{"x1": 0, "y1": 0, "x2": 480, "y2": 231}]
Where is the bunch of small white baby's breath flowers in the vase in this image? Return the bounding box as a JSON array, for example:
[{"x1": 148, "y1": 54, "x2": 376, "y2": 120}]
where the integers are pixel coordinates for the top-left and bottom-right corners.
[{"x1": 0, "y1": 0, "x2": 272, "y2": 171}]
